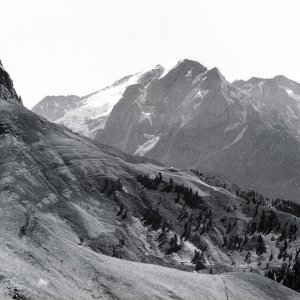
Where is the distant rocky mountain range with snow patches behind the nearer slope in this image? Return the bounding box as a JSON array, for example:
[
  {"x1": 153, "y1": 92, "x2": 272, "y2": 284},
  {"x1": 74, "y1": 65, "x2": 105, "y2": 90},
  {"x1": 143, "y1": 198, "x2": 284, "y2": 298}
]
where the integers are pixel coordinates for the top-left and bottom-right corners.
[{"x1": 33, "y1": 60, "x2": 300, "y2": 201}]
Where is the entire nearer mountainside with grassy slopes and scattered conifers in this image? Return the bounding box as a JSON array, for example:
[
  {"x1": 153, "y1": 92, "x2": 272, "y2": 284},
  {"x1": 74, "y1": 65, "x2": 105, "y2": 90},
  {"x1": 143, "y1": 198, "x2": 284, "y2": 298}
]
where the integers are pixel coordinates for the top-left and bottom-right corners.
[{"x1": 0, "y1": 61, "x2": 300, "y2": 299}]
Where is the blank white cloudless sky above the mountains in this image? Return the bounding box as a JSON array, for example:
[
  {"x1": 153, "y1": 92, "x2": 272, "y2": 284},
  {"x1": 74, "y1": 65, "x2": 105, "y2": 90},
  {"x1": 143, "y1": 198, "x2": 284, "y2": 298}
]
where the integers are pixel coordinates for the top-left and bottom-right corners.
[{"x1": 0, "y1": 0, "x2": 300, "y2": 108}]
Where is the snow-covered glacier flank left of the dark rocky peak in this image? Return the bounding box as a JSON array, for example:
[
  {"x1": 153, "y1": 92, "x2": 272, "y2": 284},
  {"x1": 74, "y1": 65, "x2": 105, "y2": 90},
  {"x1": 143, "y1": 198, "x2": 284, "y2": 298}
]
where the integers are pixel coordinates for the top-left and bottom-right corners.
[{"x1": 32, "y1": 65, "x2": 172, "y2": 138}]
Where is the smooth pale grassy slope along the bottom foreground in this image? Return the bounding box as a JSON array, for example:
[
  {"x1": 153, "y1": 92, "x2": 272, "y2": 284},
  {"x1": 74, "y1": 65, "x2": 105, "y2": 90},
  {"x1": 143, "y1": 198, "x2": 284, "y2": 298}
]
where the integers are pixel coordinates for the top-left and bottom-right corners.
[{"x1": 0, "y1": 220, "x2": 299, "y2": 300}]
